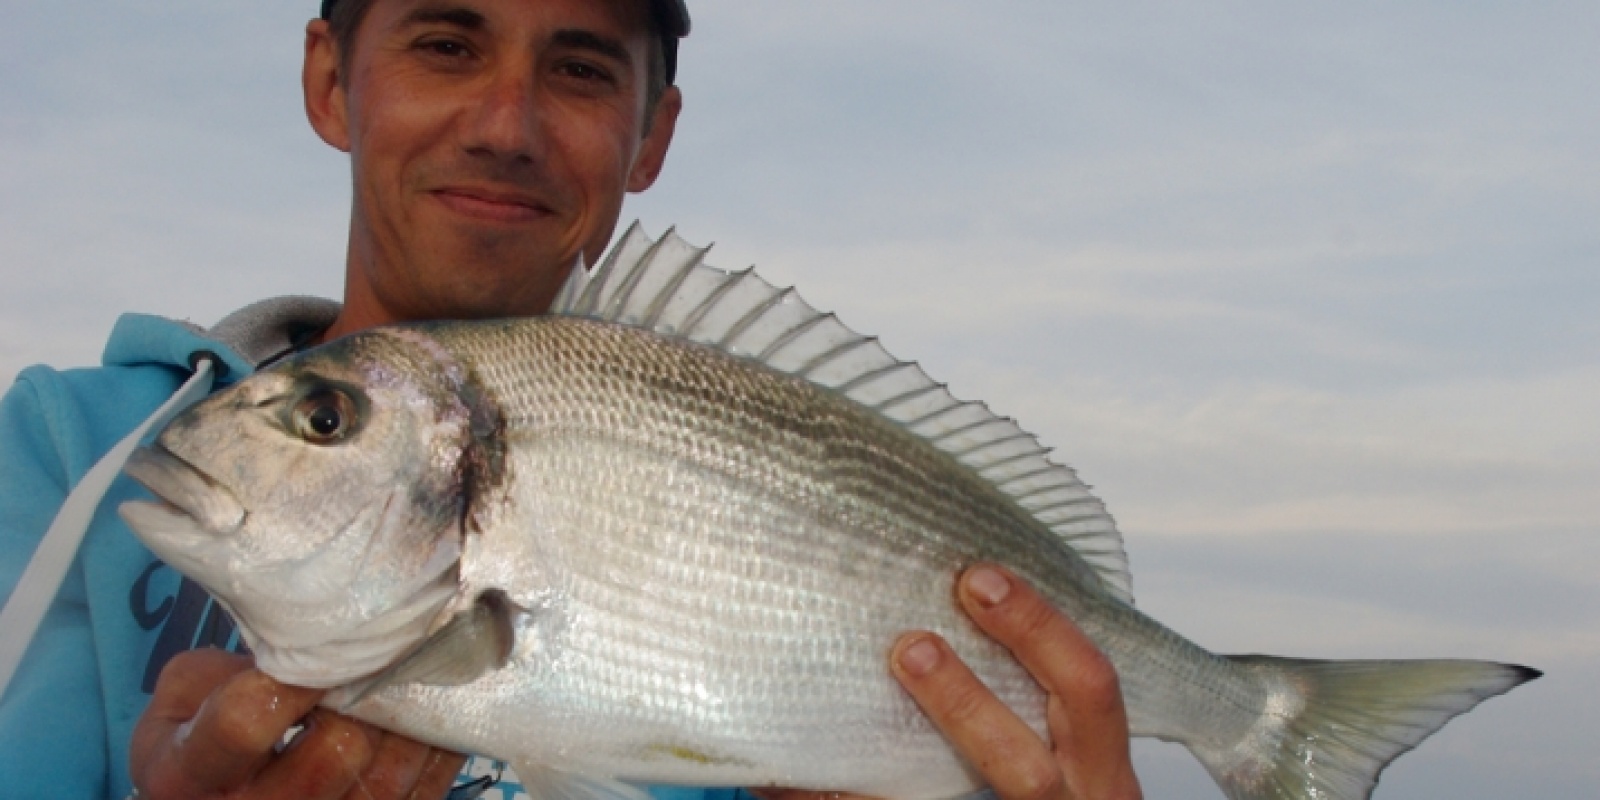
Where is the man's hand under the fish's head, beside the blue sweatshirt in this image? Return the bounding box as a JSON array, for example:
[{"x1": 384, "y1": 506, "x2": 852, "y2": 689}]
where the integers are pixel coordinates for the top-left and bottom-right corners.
[{"x1": 130, "y1": 650, "x2": 464, "y2": 800}]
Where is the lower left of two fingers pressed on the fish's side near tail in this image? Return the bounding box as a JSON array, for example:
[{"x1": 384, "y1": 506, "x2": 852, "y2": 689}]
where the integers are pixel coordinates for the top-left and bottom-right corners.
[{"x1": 890, "y1": 632, "x2": 1070, "y2": 800}]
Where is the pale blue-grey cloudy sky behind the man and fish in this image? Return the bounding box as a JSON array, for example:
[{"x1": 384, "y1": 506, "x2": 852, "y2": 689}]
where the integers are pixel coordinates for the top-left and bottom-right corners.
[{"x1": 0, "y1": 0, "x2": 1600, "y2": 800}]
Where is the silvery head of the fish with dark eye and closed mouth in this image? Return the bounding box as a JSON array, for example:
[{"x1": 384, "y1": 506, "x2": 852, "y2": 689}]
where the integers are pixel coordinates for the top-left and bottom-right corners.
[{"x1": 120, "y1": 328, "x2": 498, "y2": 686}]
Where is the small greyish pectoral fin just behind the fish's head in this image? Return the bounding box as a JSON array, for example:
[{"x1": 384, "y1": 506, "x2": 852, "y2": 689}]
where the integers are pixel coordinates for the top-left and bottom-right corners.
[{"x1": 342, "y1": 590, "x2": 517, "y2": 709}]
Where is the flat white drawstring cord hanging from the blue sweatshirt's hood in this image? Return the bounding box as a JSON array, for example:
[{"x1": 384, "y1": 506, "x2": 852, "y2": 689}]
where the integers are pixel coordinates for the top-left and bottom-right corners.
[{"x1": 0, "y1": 352, "x2": 218, "y2": 698}]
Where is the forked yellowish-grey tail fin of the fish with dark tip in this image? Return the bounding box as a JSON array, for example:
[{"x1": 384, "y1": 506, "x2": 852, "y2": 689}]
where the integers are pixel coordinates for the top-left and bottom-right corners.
[{"x1": 1192, "y1": 656, "x2": 1541, "y2": 800}]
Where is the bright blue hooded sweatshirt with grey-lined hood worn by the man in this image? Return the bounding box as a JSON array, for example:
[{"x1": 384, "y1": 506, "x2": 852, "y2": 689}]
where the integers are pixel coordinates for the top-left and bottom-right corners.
[{"x1": 0, "y1": 298, "x2": 744, "y2": 800}]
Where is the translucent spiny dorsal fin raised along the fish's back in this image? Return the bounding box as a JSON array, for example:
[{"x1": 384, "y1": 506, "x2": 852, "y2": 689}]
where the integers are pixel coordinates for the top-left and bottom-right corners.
[{"x1": 552, "y1": 222, "x2": 1133, "y2": 603}]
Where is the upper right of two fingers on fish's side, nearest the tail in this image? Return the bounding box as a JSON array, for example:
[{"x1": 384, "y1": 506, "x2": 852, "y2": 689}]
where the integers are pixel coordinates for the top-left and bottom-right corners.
[{"x1": 958, "y1": 565, "x2": 1138, "y2": 797}]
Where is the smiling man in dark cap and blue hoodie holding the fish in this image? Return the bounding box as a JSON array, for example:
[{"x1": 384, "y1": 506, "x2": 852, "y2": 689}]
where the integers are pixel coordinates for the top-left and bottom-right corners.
[{"x1": 0, "y1": 0, "x2": 1138, "y2": 798}]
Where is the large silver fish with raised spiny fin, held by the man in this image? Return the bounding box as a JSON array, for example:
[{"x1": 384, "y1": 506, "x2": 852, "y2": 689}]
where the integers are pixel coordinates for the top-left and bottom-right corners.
[{"x1": 122, "y1": 227, "x2": 1538, "y2": 800}]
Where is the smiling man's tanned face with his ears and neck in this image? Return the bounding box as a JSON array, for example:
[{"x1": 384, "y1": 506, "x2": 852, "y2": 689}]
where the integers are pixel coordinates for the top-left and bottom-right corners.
[{"x1": 307, "y1": 0, "x2": 678, "y2": 333}]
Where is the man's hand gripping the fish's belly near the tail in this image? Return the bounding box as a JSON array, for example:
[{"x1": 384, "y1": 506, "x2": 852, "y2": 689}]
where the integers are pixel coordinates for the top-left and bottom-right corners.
[{"x1": 754, "y1": 565, "x2": 1142, "y2": 800}]
